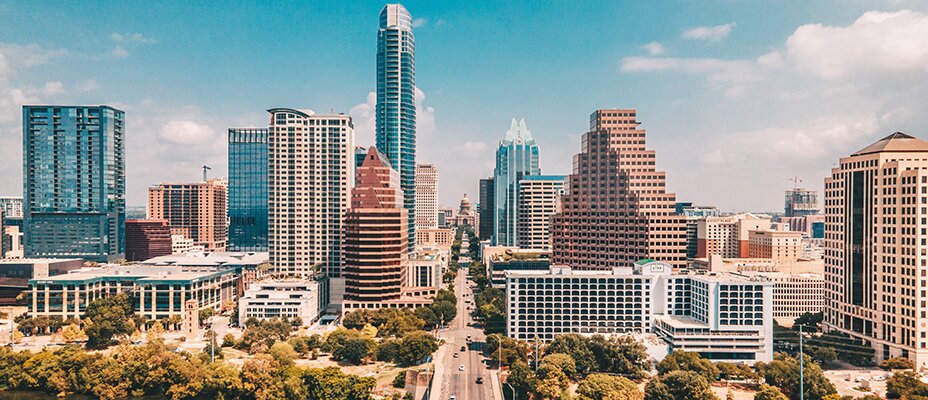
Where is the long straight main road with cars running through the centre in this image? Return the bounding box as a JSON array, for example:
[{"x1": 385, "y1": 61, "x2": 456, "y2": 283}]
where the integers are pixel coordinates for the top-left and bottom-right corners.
[{"x1": 430, "y1": 241, "x2": 499, "y2": 400}]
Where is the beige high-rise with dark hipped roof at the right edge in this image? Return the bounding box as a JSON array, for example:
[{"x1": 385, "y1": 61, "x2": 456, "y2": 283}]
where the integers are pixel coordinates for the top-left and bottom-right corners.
[{"x1": 824, "y1": 132, "x2": 928, "y2": 370}]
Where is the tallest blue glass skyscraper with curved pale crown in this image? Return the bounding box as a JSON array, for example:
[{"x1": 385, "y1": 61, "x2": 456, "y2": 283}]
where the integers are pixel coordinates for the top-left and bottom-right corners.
[{"x1": 376, "y1": 4, "x2": 416, "y2": 248}]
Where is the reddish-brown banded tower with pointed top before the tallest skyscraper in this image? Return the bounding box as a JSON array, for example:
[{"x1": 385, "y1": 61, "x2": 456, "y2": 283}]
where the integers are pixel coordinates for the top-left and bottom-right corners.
[{"x1": 344, "y1": 147, "x2": 409, "y2": 309}]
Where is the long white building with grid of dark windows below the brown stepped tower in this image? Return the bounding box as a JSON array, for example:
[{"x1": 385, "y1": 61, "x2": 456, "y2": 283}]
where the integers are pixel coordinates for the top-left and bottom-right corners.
[{"x1": 506, "y1": 259, "x2": 773, "y2": 363}]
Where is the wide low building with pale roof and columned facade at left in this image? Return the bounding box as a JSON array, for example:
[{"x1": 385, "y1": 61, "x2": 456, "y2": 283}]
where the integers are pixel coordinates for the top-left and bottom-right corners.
[{"x1": 29, "y1": 264, "x2": 238, "y2": 320}]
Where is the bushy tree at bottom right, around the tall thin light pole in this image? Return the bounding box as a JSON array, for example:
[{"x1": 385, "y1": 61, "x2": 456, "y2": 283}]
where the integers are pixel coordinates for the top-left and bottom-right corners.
[{"x1": 757, "y1": 357, "x2": 836, "y2": 400}]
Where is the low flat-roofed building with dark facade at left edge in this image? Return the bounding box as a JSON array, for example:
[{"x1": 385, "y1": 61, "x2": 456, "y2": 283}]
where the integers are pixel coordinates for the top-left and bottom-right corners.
[{"x1": 0, "y1": 258, "x2": 84, "y2": 306}]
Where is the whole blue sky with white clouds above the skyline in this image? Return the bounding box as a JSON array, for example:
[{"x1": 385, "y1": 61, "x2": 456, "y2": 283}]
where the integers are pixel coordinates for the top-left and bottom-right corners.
[{"x1": 0, "y1": 0, "x2": 928, "y2": 211}]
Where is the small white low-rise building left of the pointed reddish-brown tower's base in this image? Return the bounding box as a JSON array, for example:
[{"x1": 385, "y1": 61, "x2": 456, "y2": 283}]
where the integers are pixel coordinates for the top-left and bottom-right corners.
[{"x1": 238, "y1": 280, "x2": 328, "y2": 326}]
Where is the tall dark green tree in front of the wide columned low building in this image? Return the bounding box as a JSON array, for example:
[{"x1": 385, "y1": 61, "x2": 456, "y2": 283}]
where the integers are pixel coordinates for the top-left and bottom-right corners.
[{"x1": 84, "y1": 293, "x2": 135, "y2": 349}]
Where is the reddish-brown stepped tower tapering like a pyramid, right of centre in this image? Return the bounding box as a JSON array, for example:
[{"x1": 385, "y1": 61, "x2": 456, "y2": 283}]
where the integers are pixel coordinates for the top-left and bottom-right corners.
[{"x1": 551, "y1": 109, "x2": 686, "y2": 270}]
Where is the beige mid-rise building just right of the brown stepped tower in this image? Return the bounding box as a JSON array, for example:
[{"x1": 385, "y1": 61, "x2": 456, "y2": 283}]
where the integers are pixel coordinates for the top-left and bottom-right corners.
[{"x1": 696, "y1": 213, "x2": 771, "y2": 258}]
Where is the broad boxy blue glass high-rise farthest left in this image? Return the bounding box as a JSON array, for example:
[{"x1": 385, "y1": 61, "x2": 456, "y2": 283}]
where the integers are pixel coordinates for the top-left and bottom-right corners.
[{"x1": 23, "y1": 105, "x2": 126, "y2": 261}]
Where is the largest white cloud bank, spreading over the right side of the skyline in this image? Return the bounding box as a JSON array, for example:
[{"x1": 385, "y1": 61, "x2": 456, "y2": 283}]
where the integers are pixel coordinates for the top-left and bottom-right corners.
[{"x1": 619, "y1": 11, "x2": 928, "y2": 211}]
